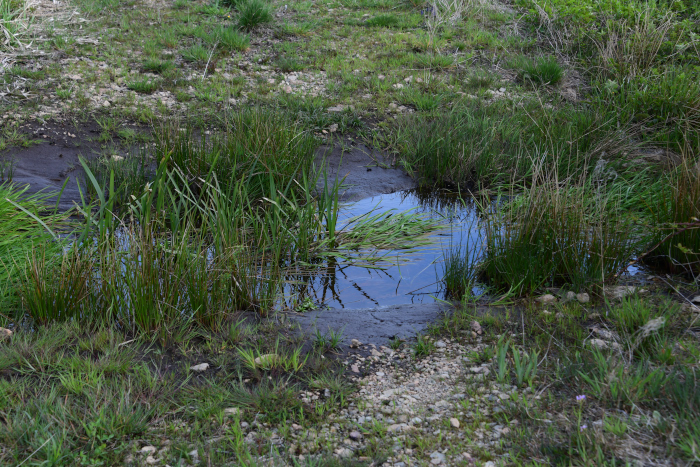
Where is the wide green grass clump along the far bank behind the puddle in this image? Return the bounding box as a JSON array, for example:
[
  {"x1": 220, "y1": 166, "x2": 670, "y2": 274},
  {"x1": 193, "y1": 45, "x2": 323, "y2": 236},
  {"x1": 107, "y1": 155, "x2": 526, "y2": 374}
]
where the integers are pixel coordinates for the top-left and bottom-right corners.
[{"x1": 387, "y1": 102, "x2": 635, "y2": 189}]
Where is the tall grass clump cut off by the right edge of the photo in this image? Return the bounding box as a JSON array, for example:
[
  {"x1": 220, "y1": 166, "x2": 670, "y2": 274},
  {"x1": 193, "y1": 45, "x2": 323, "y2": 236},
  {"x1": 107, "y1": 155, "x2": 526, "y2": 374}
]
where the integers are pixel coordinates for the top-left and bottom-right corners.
[{"x1": 644, "y1": 158, "x2": 700, "y2": 275}]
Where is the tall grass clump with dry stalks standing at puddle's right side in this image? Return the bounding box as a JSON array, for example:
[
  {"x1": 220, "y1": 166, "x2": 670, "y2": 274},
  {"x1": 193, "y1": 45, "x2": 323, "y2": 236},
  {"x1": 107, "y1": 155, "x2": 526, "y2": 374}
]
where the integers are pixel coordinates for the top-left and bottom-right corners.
[{"x1": 482, "y1": 167, "x2": 637, "y2": 294}]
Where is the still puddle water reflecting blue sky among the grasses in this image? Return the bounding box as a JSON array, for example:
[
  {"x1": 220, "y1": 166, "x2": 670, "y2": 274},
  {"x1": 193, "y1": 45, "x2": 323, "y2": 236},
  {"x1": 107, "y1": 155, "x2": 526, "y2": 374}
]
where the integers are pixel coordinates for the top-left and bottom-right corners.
[{"x1": 285, "y1": 190, "x2": 478, "y2": 310}]
